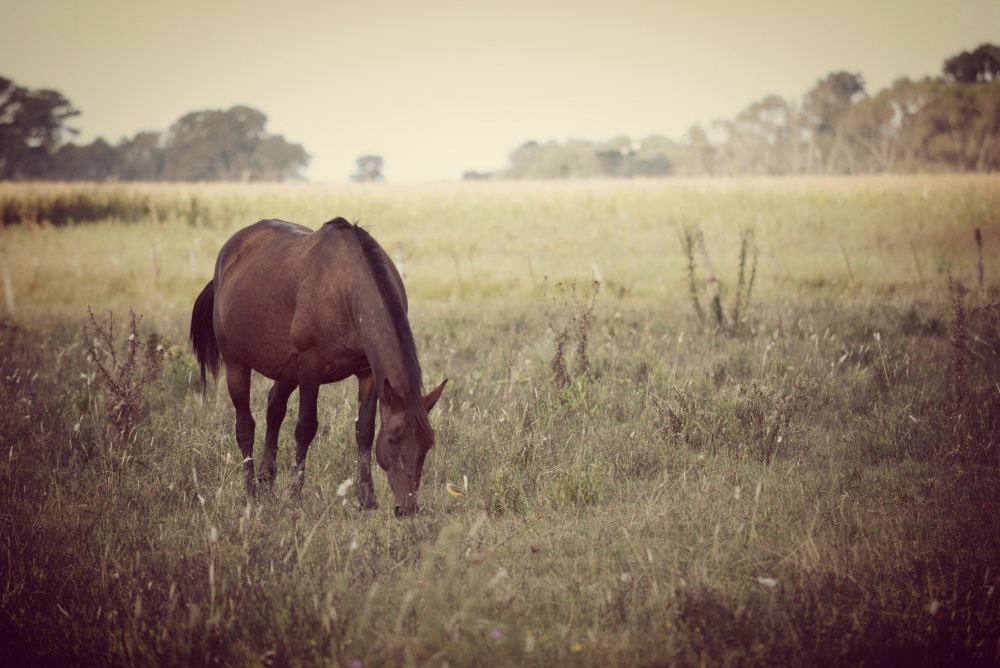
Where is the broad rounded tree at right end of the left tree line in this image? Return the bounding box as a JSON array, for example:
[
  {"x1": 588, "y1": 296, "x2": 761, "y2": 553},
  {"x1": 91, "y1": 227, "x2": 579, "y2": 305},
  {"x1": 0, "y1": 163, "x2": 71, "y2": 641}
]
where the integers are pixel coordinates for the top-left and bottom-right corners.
[{"x1": 163, "y1": 106, "x2": 309, "y2": 181}]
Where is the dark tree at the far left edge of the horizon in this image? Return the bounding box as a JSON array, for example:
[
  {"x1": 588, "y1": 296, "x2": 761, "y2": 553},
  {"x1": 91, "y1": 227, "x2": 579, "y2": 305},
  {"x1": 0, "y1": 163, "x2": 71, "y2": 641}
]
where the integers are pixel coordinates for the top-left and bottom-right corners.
[{"x1": 0, "y1": 77, "x2": 80, "y2": 180}]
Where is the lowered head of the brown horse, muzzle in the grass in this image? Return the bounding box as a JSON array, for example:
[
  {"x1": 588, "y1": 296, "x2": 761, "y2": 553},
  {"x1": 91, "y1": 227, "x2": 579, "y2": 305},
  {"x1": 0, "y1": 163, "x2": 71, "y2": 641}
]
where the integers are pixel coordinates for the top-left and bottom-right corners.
[{"x1": 375, "y1": 379, "x2": 448, "y2": 517}]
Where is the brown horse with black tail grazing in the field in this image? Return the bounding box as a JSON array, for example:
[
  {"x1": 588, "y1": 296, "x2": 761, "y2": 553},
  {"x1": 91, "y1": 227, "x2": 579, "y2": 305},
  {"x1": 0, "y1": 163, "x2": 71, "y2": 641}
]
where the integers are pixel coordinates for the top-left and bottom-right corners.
[{"x1": 191, "y1": 218, "x2": 447, "y2": 517}]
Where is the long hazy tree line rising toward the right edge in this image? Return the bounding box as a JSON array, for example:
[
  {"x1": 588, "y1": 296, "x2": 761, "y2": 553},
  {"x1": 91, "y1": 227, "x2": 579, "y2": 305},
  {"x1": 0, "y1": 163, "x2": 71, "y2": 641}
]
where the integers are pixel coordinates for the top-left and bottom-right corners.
[{"x1": 465, "y1": 44, "x2": 1000, "y2": 179}]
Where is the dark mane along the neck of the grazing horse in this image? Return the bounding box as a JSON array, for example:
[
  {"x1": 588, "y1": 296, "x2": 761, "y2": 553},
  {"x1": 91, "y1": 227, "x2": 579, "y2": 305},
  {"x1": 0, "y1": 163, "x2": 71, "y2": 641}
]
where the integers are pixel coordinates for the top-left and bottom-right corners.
[{"x1": 327, "y1": 218, "x2": 434, "y2": 447}]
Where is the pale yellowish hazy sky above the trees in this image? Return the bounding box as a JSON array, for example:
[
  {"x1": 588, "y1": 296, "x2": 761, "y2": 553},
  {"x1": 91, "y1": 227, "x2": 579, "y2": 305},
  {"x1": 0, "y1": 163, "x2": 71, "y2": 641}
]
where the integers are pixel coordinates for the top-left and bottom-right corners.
[{"x1": 0, "y1": 0, "x2": 1000, "y2": 182}]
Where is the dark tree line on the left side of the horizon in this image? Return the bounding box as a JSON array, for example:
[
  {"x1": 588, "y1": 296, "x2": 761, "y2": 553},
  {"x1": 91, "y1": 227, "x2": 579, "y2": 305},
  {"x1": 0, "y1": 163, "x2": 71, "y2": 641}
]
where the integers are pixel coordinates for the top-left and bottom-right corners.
[{"x1": 0, "y1": 77, "x2": 310, "y2": 181}]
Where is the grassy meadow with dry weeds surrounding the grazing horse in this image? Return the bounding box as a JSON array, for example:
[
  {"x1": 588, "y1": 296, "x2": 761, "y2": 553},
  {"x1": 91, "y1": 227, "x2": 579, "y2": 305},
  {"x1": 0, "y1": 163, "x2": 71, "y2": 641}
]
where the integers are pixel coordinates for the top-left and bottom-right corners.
[{"x1": 0, "y1": 176, "x2": 1000, "y2": 667}]
